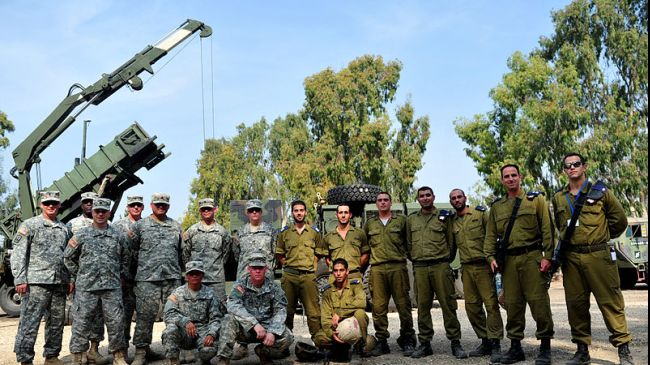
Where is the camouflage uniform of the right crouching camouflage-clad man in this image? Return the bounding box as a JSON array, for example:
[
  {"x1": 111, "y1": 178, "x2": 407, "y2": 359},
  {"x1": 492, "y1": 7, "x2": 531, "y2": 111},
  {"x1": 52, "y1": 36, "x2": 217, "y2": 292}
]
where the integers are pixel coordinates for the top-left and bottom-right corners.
[{"x1": 218, "y1": 273, "x2": 293, "y2": 359}]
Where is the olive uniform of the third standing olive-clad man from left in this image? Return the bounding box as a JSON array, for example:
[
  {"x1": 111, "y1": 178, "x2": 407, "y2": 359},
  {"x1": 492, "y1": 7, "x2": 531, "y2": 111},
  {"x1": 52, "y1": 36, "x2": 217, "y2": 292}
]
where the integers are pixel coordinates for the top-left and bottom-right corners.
[{"x1": 364, "y1": 213, "x2": 415, "y2": 340}]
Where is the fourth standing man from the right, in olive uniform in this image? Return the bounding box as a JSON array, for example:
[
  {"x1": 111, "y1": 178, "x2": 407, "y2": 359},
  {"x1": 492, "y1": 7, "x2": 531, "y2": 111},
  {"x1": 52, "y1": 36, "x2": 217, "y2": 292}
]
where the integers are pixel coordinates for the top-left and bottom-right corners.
[{"x1": 406, "y1": 186, "x2": 467, "y2": 359}]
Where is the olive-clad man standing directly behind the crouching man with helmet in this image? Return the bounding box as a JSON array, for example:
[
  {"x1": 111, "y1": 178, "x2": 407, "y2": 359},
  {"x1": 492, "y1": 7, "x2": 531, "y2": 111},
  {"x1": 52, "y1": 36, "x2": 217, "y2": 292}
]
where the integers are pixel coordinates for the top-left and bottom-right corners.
[{"x1": 323, "y1": 204, "x2": 370, "y2": 282}]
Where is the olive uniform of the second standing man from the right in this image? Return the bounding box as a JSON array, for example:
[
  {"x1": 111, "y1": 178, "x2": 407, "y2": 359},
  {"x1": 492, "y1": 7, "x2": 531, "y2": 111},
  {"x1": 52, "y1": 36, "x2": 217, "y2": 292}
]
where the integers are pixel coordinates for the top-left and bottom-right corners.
[{"x1": 484, "y1": 191, "x2": 554, "y2": 340}]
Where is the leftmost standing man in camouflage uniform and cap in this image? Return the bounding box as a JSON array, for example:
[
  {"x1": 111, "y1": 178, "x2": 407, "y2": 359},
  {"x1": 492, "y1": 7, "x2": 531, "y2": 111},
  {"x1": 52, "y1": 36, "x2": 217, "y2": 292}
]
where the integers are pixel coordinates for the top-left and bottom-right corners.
[{"x1": 10, "y1": 191, "x2": 71, "y2": 365}]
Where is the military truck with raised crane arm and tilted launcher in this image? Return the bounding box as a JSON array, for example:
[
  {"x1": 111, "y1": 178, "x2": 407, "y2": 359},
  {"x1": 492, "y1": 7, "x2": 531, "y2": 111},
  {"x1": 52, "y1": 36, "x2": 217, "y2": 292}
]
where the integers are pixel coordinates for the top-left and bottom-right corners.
[{"x1": 0, "y1": 19, "x2": 212, "y2": 316}]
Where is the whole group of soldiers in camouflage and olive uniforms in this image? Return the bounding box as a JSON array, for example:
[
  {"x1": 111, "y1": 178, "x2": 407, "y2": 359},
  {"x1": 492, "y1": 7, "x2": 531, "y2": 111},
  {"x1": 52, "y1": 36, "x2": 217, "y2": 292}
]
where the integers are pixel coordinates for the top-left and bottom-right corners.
[{"x1": 11, "y1": 153, "x2": 633, "y2": 365}]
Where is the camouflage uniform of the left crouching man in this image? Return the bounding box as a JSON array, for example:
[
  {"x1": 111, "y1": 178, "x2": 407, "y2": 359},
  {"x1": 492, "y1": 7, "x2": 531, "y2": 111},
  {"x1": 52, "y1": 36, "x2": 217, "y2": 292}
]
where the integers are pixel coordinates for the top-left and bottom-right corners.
[{"x1": 162, "y1": 284, "x2": 224, "y2": 361}]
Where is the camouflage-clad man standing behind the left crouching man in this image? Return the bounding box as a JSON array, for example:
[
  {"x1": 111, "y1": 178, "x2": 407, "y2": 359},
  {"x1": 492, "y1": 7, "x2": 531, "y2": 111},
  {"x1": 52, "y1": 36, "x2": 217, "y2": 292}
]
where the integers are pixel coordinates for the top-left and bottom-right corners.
[{"x1": 182, "y1": 198, "x2": 232, "y2": 307}]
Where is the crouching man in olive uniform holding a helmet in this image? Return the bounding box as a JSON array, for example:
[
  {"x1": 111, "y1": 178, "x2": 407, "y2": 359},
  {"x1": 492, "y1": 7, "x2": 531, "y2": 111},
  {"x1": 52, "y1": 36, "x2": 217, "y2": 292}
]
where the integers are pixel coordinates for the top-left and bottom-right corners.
[{"x1": 316, "y1": 258, "x2": 368, "y2": 361}]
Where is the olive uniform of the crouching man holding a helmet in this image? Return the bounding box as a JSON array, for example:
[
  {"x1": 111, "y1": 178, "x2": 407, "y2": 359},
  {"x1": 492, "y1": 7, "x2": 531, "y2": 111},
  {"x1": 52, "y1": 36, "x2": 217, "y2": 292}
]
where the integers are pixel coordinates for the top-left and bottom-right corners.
[{"x1": 316, "y1": 277, "x2": 368, "y2": 346}]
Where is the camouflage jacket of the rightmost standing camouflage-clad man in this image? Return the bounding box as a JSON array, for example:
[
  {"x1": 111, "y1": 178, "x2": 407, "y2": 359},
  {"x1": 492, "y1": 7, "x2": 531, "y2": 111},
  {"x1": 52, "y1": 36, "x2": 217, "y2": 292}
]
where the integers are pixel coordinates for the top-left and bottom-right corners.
[{"x1": 232, "y1": 222, "x2": 276, "y2": 278}]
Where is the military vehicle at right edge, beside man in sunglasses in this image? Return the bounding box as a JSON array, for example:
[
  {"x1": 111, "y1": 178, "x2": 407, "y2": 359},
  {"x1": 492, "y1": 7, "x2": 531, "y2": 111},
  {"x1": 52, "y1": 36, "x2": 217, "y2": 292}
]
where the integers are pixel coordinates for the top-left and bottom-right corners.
[{"x1": 610, "y1": 217, "x2": 648, "y2": 289}]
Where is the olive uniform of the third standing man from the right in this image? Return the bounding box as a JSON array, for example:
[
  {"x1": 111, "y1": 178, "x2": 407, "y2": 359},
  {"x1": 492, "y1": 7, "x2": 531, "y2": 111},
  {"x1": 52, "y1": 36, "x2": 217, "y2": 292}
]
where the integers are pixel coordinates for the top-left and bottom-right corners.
[{"x1": 452, "y1": 207, "x2": 503, "y2": 339}]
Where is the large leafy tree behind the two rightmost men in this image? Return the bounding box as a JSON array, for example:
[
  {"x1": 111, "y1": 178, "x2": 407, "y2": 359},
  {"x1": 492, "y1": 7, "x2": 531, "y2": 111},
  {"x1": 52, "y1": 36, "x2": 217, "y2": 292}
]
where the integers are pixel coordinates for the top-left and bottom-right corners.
[{"x1": 455, "y1": 0, "x2": 648, "y2": 212}]
